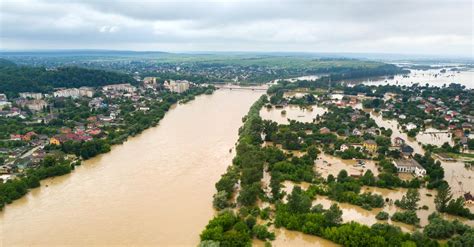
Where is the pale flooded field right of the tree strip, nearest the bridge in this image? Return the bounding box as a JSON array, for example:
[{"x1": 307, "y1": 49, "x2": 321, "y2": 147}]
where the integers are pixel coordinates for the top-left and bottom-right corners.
[{"x1": 260, "y1": 105, "x2": 326, "y2": 124}]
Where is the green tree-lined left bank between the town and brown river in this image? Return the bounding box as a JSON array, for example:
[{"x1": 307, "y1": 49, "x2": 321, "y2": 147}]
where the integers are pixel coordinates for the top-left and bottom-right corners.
[{"x1": 0, "y1": 87, "x2": 214, "y2": 210}]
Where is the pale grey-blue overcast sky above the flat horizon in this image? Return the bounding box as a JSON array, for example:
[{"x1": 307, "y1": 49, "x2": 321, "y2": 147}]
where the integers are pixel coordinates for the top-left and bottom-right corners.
[{"x1": 0, "y1": 0, "x2": 474, "y2": 57}]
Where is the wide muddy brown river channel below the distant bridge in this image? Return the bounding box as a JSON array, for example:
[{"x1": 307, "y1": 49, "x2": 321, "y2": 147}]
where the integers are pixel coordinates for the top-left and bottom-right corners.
[{"x1": 0, "y1": 90, "x2": 263, "y2": 246}]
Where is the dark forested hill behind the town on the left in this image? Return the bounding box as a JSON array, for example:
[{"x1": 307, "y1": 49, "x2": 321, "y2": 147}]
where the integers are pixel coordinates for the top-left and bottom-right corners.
[{"x1": 0, "y1": 59, "x2": 135, "y2": 97}]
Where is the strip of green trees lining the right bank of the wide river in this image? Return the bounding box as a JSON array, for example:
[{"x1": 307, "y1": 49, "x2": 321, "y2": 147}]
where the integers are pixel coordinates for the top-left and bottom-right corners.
[{"x1": 205, "y1": 96, "x2": 272, "y2": 246}]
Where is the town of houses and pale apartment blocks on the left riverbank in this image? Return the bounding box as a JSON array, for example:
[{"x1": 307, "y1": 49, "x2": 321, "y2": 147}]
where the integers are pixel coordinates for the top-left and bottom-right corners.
[{"x1": 0, "y1": 77, "x2": 213, "y2": 194}]
